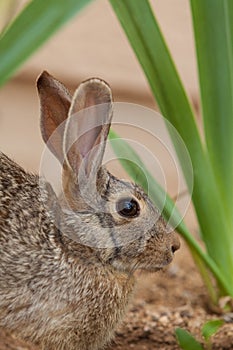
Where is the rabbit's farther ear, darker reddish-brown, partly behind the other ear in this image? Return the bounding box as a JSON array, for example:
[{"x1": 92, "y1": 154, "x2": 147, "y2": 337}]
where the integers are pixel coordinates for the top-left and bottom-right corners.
[{"x1": 37, "y1": 71, "x2": 72, "y2": 163}]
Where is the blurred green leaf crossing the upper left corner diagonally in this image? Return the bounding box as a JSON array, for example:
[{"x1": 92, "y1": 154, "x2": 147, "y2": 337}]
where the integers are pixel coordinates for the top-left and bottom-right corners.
[{"x1": 0, "y1": 0, "x2": 91, "y2": 85}]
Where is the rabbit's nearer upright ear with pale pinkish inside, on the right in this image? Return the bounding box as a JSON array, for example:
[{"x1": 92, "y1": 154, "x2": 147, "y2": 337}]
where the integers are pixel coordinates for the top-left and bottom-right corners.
[{"x1": 64, "y1": 78, "x2": 112, "y2": 177}]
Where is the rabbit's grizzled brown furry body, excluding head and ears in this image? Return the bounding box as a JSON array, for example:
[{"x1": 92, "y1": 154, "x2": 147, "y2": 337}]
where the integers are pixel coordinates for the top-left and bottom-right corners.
[{"x1": 0, "y1": 153, "x2": 134, "y2": 350}]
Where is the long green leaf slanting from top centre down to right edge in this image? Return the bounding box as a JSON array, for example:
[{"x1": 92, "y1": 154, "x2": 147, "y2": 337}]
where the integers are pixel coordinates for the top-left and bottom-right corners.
[{"x1": 110, "y1": 0, "x2": 233, "y2": 296}]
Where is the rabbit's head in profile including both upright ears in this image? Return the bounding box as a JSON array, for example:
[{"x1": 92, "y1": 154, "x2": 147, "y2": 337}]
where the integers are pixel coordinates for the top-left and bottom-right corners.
[{"x1": 38, "y1": 72, "x2": 180, "y2": 272}]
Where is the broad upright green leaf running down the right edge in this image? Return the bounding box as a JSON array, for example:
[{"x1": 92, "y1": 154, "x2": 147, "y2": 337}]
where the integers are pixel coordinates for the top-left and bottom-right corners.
[{"x1": 191, "y1": 0, "x2": 233, "y2": 221}]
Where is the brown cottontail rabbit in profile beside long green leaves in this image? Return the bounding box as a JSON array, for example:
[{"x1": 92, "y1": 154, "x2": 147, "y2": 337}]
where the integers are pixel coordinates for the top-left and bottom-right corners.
[{"x1": 0, "y1": 72, "x2": 179, "y2": 350}]
